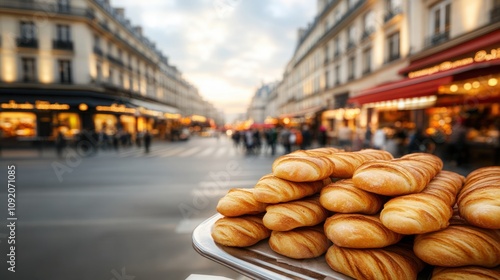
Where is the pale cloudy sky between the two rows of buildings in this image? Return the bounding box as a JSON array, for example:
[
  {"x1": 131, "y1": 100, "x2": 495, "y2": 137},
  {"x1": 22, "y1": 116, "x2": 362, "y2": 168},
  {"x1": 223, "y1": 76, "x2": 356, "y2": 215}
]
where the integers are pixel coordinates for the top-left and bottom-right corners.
[{"x1": 115, "y1": 0, "x2": 316, "y2": 122}]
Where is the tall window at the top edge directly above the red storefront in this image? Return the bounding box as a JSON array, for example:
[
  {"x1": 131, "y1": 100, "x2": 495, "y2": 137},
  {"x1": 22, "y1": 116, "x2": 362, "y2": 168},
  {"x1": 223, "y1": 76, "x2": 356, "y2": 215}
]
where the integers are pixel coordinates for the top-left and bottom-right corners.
[{"x1": 428, "y1": 0, "x2": 451, "y2": 45}]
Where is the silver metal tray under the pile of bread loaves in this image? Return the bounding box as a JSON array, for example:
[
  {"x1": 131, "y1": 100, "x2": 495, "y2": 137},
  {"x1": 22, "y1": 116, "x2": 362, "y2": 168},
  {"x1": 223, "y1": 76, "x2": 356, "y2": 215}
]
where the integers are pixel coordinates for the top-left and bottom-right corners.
[{"x1": 193, "y1": 214, "x2": 352, "y2": 280}]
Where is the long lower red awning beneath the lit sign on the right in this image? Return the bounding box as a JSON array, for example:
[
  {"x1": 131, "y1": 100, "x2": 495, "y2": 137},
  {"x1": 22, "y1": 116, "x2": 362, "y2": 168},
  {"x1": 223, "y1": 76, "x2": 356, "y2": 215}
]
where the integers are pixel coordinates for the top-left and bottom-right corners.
[{"x1": 348, "y1": 60, "x2": 500, "y2": 105}]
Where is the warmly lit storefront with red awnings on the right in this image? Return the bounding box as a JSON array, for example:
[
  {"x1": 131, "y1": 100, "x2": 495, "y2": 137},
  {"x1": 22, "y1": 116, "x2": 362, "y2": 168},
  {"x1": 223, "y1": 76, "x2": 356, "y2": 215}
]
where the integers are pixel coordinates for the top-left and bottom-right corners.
[{"x1": 348, "y1": 30, "x2": 500, "y2": 161}]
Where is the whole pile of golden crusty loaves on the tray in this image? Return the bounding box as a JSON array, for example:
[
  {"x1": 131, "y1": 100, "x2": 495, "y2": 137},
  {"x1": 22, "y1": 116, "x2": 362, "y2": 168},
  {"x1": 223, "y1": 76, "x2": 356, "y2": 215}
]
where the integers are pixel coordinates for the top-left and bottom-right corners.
[{"x1": 212, "y1": 148, "x2": 500, "y2": 279}]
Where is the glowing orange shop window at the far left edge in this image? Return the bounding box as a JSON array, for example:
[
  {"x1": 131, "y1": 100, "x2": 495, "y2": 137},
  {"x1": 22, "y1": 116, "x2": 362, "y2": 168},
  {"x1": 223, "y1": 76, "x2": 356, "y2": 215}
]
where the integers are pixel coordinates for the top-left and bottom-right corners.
[{"x1": 0, "y1": 112, "x2": 36, "y2": 138}]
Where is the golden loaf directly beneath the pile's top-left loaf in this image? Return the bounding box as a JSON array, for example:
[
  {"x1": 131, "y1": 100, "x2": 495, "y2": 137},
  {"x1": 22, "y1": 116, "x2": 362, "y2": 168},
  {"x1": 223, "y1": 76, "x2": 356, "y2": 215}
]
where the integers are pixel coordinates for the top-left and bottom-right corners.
[{"x1": 253, "y1": 174, "x2": 324, "y2": 203}]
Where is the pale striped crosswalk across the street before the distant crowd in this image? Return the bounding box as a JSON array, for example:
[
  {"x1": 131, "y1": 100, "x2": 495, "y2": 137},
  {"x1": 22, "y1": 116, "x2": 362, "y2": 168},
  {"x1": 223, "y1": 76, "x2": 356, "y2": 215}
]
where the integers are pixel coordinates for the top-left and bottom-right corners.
[{"x1": 99, "y1": 146, "x2": 280, "y2": 159}]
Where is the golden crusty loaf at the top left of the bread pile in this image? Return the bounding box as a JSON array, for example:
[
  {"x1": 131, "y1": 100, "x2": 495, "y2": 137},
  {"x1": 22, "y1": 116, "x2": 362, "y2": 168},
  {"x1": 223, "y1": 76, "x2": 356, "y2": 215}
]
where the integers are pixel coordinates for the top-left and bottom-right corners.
[{"x1": 272, "y1": 148, "x2": 336, "y2": 182}]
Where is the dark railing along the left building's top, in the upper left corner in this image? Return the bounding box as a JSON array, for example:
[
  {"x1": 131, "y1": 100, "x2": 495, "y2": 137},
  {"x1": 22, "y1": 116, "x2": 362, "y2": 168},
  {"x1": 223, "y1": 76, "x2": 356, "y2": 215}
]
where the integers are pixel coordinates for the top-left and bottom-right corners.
[{"x1": 0, "y1": 0, "x2": 95, "y2": 19}]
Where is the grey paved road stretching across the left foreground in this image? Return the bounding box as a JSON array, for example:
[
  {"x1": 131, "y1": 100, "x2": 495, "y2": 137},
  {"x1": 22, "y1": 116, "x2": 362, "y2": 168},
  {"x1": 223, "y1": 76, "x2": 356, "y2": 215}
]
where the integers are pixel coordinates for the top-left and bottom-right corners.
[{"x1": 0, "y1": 138, "x2": 274, "y2": 280}]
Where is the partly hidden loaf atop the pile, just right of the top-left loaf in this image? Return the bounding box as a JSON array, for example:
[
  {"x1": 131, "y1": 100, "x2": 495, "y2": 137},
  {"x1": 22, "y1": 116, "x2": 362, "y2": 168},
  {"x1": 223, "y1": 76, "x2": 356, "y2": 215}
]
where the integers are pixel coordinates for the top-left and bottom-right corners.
[{"x1": 327, "y1": 149, "x2": 393, "y2": 178}]
